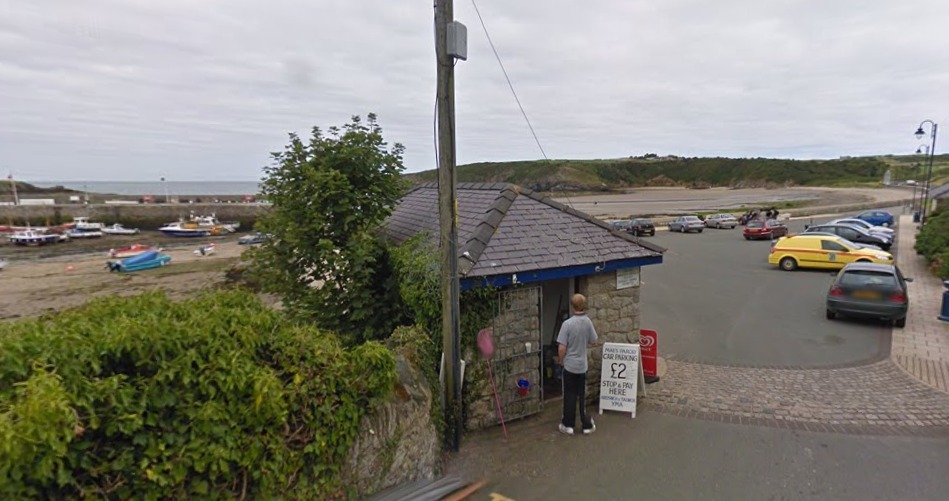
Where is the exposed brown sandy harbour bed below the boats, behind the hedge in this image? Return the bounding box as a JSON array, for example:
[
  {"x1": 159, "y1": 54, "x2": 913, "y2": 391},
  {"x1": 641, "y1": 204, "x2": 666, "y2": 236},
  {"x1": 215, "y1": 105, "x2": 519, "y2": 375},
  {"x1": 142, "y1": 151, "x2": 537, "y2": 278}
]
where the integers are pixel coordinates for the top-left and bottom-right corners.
[{"x1": 0, "y1": 240, "x2": 246, "y2": 320}]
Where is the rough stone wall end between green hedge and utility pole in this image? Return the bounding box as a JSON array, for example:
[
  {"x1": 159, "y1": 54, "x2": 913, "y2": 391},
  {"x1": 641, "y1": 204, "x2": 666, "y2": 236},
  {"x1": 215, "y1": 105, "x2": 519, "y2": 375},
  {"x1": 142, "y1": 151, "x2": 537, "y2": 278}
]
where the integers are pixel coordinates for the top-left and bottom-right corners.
[{"x1": 343, "y1": 356, "x2": 438, "y2": 496}]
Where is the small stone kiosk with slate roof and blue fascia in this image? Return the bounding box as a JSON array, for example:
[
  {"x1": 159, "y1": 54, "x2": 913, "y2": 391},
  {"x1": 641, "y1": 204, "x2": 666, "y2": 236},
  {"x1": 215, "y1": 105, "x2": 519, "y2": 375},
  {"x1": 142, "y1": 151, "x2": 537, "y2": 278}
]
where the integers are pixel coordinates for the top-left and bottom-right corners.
[{"x1": 385, "y1": 183, "x2": 665, "y2": 429}]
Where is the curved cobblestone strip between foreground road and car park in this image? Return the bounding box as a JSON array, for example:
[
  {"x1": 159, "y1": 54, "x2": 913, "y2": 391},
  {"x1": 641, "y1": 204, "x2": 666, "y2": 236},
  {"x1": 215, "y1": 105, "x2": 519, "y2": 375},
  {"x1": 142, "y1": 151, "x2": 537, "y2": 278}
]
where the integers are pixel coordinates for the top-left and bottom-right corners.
[{"x1": 644, "y1": 360, "x2": 949, "y2": 435}]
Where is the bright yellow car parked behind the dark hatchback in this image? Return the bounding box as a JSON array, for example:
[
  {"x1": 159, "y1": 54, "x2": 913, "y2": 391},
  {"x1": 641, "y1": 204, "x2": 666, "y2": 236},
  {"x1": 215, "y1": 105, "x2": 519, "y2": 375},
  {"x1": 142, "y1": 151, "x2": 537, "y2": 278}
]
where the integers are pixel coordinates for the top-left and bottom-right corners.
[{"x1": 768, "y1": 234, "x2": 893, "y2": 271}]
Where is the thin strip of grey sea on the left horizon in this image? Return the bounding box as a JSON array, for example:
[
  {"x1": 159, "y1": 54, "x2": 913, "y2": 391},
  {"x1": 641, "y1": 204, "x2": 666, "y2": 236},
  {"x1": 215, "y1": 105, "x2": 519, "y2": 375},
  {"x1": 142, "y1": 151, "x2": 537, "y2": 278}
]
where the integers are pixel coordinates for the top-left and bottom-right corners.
[{"x1": 26, "y1": 181, "x2": 260, "y2": 196}]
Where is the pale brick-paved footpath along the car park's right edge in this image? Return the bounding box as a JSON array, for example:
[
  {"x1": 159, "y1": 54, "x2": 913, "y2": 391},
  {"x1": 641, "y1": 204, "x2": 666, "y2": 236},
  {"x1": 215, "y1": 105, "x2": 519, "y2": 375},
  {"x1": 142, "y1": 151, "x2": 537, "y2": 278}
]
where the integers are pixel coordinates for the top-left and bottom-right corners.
[{"x1": 891, "y1": 215, "x2": 949, "y2": 393}]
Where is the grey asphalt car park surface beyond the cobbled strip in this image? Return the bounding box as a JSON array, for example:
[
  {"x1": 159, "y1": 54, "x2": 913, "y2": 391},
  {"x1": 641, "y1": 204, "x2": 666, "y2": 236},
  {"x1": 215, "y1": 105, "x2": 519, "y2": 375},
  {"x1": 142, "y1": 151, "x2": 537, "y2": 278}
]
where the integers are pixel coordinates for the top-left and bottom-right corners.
[{"x1": 641, "y1": 219, "x2": 890, "y2": 367}]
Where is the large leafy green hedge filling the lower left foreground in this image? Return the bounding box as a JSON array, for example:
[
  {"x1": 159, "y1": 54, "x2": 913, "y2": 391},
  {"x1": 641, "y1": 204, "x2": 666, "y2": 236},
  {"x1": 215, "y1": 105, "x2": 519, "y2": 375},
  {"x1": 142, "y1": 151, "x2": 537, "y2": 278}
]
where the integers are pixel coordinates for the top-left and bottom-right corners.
[{"x1": 0, "y1": 291, "x2": 395, "y2": 499}]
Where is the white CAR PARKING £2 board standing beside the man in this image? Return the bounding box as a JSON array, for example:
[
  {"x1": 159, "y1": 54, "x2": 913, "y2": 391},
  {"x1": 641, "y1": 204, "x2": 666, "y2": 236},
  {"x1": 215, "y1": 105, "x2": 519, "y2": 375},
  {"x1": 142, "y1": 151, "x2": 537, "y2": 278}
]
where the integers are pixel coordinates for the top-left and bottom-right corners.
[{"x1": 600, "y1": 343, "x2": 642, "y2": 418}]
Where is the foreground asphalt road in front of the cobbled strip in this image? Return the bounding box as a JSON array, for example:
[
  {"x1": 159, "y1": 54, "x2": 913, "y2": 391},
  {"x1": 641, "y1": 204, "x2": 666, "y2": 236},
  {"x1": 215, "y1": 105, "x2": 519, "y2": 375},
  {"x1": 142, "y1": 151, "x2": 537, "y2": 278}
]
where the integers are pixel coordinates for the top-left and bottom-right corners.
[{"x1": 449, "y1": 413, "x2": 949, "y2": 501}]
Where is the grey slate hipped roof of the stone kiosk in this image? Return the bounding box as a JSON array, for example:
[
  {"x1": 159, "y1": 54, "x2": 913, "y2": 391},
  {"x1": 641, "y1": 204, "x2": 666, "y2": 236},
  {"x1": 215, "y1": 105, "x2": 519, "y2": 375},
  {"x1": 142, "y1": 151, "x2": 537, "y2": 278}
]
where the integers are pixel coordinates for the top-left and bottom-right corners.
[{"x1": 384, "y1": 183, "x2": 665, "y2": 277}]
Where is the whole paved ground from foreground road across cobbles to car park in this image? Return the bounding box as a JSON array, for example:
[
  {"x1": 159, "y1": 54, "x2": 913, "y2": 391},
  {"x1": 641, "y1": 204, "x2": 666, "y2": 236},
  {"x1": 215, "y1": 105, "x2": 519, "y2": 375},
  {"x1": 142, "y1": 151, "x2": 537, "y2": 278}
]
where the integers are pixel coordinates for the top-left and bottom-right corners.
[{"x1": 447, "y1": 205, "x2": 949, "y2": 501}]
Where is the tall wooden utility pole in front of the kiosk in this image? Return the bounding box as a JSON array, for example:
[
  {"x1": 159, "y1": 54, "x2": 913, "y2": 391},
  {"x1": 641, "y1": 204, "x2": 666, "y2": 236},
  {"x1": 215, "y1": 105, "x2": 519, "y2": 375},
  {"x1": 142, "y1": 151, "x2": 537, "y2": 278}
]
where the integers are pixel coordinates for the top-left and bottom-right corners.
[{"x1": 435, "y1": 0, "x2": 462, "y2": 451}]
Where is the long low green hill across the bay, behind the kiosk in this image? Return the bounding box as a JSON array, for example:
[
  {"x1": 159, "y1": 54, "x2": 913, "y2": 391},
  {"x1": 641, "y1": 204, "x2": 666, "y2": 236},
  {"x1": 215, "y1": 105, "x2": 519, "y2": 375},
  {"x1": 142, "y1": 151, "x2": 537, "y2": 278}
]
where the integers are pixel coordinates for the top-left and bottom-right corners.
[{"x1": 407, "y1": 155, "x2": 949, "y2": 191}]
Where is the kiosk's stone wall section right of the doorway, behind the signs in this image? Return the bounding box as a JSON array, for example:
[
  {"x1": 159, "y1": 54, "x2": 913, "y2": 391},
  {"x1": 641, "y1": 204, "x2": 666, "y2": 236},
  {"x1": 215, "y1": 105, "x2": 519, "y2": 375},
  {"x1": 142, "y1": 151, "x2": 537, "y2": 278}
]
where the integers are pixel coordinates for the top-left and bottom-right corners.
[{"x1": 580, "y1": 271, "x2": 640, "y2": 402}]
